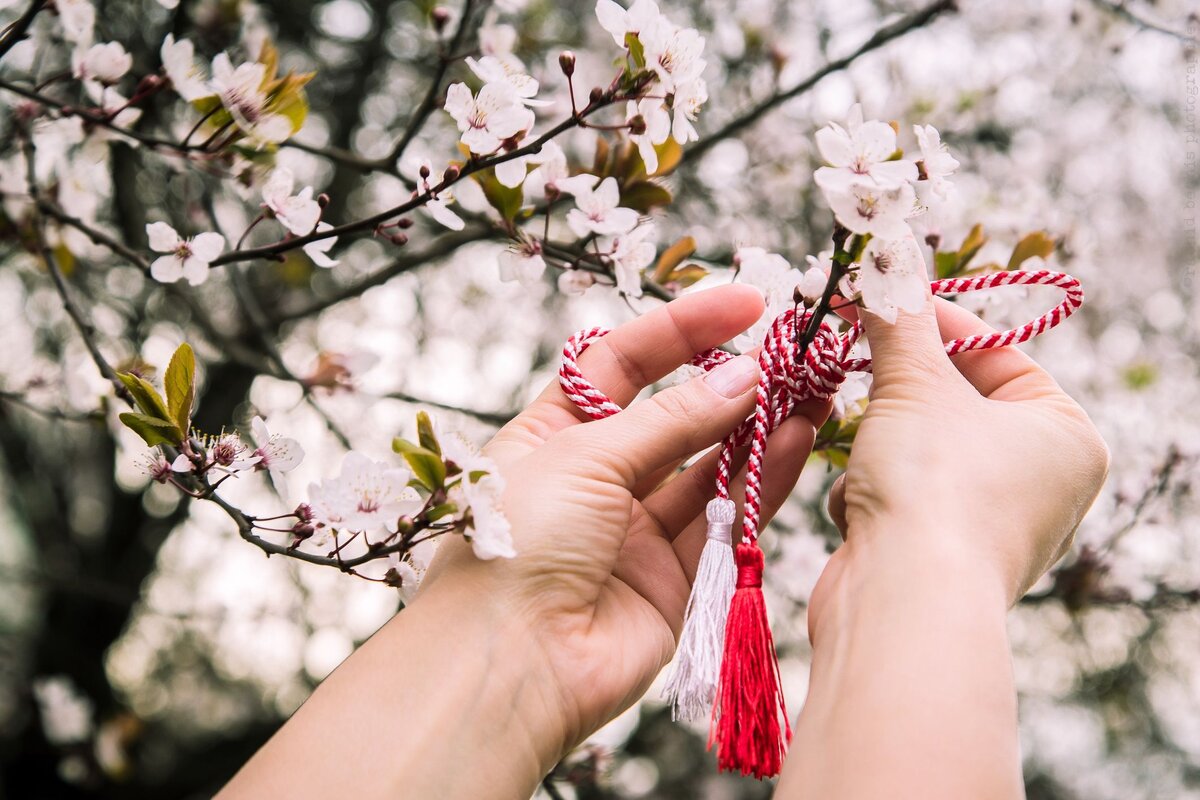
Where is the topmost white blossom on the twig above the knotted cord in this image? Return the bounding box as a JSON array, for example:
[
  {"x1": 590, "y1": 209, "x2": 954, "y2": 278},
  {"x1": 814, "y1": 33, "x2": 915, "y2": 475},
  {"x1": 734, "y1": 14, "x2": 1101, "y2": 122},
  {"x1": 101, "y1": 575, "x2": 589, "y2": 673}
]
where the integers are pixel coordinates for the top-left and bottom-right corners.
[{"x1": 812, "y1": 103, "x2": 917, "y2": 196}]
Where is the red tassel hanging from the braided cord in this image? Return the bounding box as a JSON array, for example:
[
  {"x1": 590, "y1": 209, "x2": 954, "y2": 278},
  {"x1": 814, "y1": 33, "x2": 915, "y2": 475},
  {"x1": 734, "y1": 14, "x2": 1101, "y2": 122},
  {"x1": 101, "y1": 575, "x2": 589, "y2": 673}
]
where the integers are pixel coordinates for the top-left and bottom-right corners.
[{"x1": 708, "y1": 541, "x2": 792, "y2": 780}]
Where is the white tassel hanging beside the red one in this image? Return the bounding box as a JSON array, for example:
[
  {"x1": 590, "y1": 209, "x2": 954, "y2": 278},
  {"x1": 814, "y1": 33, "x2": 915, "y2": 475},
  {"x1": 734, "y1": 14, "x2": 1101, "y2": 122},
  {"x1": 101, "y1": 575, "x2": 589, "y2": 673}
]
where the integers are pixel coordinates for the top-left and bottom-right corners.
[{"x1": 662, "y1": 498, "x2": 738, "y2": 720}]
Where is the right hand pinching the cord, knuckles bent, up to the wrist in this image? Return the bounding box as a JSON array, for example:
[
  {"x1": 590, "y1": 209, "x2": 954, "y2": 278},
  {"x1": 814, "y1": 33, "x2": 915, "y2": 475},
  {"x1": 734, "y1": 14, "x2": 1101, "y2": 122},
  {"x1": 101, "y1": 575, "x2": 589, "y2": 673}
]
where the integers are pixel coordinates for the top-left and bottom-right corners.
[{"x1": 809, "y1": 278, "x2": 1109, "y2": 630}]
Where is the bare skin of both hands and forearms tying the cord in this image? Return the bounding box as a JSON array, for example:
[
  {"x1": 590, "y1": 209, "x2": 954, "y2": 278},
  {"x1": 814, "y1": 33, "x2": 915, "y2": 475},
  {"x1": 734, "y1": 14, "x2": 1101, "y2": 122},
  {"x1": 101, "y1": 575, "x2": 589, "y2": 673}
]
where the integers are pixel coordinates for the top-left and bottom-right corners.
[{"x1": 220, "y1": 278, "x2": 1108, "y2": 800}]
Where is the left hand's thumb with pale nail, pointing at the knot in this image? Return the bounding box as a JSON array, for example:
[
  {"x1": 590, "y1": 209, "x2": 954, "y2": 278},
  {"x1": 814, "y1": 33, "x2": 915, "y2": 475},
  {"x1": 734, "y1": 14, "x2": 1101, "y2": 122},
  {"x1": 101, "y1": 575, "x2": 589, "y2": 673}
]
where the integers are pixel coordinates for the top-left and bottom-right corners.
[{"x1": 571, "y1": 355, "x2": 758, "y2": 488}]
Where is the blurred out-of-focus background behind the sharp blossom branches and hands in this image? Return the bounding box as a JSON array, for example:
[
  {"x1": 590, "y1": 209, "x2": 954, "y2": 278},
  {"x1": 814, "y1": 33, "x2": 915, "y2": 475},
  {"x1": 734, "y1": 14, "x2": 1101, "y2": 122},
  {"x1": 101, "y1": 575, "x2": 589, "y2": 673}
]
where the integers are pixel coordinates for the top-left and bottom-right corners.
[{"x1": 0, "y1": 0, "x2": 1200, "y2": 800}]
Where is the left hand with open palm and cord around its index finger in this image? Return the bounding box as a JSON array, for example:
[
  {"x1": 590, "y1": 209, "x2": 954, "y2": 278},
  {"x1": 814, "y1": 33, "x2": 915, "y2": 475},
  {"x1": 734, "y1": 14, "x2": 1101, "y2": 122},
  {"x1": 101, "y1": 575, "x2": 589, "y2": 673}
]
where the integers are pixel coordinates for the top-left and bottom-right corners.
[{"x1": 412, "y1": 285, "x2": 828, "y2": 769}]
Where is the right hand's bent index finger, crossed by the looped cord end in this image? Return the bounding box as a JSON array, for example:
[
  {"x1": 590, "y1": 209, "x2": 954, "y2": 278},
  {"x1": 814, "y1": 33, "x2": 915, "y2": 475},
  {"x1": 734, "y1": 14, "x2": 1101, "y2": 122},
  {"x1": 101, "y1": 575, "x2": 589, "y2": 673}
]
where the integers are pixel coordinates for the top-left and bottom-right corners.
[{"x1": 934, "y1": 297, "x2": 1060, "y2": 401}]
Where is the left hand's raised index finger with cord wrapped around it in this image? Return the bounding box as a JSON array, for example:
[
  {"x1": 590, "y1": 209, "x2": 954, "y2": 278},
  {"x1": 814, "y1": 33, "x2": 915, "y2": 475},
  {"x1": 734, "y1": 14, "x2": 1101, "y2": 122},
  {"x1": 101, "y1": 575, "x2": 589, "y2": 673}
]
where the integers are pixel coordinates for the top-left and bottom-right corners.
[{"x1": 488, "y1": 284, "x2": 763, "y2": 462}]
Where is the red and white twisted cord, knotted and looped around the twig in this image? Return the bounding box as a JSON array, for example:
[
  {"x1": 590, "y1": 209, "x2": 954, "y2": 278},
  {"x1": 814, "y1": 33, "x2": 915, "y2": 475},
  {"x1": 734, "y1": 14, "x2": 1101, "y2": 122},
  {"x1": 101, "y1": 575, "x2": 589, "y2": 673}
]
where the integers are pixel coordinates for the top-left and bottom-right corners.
[{"x1": 558, "y1": 270, "x2": 1084, "y2": 543}]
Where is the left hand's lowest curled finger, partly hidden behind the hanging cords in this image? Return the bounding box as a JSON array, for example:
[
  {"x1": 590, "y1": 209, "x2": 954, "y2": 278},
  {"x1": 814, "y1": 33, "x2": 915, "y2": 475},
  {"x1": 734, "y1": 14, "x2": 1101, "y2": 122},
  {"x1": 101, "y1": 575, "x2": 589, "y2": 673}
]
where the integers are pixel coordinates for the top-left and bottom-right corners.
[{"x1": 672, "y1": 416, "x2": 816, "y2": 585}]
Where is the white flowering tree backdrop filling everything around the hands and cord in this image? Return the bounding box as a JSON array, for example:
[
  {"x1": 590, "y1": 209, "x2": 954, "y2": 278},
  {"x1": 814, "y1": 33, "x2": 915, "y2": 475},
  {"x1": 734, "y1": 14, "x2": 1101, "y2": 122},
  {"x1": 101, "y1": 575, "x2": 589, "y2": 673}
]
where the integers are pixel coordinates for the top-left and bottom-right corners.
[{"x1": 0, "y1": 0, "x2": 1200, "y2": 798}]
